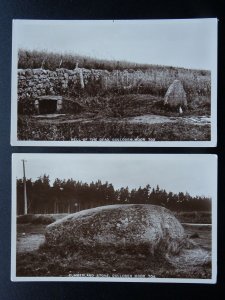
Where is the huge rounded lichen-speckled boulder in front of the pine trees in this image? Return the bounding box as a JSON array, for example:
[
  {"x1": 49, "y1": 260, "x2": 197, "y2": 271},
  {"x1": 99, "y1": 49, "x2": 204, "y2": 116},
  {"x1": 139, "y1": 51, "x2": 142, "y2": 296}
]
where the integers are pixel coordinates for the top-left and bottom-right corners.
[{"x1": 45, "y1": 204, "x2": 186, "y2": 255}]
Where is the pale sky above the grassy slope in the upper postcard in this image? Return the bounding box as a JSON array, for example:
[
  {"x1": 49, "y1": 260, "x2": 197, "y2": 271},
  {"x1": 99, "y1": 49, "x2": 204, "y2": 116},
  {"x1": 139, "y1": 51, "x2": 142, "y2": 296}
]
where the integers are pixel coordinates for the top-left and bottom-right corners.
[{"x1": 13, "y1": 19, "x2": 217, "y2": 70}]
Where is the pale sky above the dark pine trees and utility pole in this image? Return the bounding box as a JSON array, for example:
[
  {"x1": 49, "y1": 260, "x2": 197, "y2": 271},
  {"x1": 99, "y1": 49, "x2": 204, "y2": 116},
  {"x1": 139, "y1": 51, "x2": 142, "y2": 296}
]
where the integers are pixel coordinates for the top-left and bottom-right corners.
[{"x1": 13, "y1": 154, "x2": 217, "y2": 197}]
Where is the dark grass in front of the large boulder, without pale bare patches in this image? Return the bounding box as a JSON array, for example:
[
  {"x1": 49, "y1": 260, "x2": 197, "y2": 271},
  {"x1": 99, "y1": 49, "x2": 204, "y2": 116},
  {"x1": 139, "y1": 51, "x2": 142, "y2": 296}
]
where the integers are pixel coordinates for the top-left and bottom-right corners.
[{"x1": 17, "y1": 225, "x2": 211, "y2": 278}]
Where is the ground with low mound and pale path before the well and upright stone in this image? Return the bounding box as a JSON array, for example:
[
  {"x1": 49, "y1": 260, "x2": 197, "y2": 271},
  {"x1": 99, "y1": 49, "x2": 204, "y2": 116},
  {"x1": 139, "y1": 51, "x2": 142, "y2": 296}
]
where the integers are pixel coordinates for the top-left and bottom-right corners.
[{"x1": 18, "y1": 95, "x2": 211, "y2": 141}]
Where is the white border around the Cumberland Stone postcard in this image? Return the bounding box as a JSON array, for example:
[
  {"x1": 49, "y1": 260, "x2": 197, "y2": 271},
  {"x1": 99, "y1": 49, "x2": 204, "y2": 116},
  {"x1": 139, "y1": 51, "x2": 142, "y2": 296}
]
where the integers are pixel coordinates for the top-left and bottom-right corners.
[{"x1": 11, "y1": 153, "x2": 218, "y2": 284}]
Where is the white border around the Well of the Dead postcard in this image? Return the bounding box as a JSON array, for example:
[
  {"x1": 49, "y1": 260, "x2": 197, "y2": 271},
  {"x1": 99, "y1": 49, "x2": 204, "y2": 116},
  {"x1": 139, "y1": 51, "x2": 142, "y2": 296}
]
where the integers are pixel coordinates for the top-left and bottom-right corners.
[{"x1": 10, "y1": 18, "x2": 218, "y2": 147}]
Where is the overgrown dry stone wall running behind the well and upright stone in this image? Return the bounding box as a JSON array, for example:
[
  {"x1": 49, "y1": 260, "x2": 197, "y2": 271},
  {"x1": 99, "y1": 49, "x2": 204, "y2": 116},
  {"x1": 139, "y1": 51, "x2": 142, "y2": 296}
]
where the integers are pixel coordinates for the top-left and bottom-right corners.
[{"x1": 18, "y1": 68, "x2": 210, "y2": 100}]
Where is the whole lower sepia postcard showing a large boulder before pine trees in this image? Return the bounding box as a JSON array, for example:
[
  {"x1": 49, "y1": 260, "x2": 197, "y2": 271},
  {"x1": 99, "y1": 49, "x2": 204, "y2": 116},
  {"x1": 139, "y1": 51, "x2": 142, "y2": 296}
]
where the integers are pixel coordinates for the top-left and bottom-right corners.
[{"x1": 11, "y1": 153, "x2": 217, "y2": 283}]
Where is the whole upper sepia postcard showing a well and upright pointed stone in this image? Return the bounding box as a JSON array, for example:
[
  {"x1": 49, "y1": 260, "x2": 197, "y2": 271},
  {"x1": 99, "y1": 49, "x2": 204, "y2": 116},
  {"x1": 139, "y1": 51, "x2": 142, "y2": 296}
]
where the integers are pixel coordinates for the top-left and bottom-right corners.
[{"x1": 11, "y1": 19, "x2": 218, "y2": 147}]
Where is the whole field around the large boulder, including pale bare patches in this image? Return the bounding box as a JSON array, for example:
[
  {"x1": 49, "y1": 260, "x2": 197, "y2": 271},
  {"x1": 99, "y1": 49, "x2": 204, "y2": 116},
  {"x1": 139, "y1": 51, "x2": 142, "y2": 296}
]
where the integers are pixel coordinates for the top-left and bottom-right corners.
[{"x1": 16, "y1": 213, "x2": 211, "y2": 278}]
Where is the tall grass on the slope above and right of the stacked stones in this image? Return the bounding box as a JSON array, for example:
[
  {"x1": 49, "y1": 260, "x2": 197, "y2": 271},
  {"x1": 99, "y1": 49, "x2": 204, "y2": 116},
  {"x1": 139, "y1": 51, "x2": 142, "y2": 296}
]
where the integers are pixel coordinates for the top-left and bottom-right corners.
[{"x1": 18, "y1": 50, "x2": 211, "y2": 105}]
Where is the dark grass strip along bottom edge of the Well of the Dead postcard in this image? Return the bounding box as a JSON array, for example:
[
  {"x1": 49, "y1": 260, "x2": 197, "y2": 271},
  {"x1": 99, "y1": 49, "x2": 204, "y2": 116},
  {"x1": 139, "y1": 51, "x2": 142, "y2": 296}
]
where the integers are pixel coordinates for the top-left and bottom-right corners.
[{"x1": 18, "y1": 116, "x2": 210, "y2": 141}]
